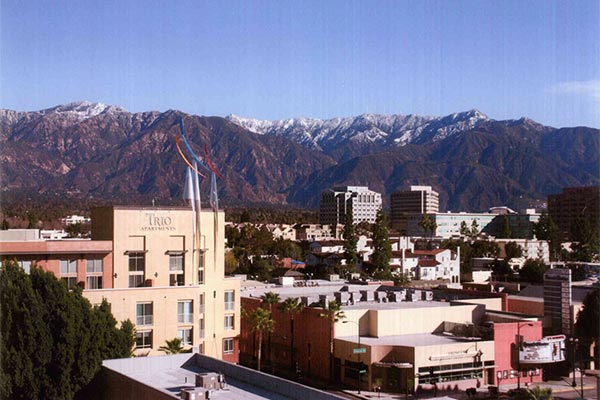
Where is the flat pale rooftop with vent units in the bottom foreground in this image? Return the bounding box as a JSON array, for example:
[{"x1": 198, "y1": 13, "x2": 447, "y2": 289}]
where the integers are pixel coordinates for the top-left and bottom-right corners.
[{"x1": 84, "y1": 354, "x2": 340, "y2": 400}]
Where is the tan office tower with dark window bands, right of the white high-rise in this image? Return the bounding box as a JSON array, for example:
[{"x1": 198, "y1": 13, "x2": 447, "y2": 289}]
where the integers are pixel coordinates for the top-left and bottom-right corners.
[{"x1": 390, "y1": 186, "x2": 440, "y2": 233}]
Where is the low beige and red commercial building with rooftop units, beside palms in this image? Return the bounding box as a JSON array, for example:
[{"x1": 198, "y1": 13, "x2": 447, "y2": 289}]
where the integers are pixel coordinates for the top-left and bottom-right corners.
[{"x1": 240, "y1": 282, "x2": 542, "y2": 392}]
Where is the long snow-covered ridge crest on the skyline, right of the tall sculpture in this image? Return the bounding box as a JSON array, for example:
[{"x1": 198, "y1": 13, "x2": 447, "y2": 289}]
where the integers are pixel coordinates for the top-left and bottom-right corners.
[{"x1": 226, "y1": 110, "x2": 490, "y2": 153}]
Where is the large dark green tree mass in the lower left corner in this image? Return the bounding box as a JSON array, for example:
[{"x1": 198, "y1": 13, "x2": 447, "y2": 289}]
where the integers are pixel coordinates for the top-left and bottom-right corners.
[{"x1": 0, "y1": 262, "x2": 134, "y2": 399}]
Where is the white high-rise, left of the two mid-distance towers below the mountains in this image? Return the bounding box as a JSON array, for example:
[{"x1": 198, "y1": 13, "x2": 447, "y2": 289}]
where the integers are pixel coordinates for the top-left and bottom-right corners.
[{"x1": 319, "y1": 186, "x2": 382, "y2": 225}]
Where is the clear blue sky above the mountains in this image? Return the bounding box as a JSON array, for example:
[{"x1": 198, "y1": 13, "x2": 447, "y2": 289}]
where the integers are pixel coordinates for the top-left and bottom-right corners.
[{"x1": 0, "y1": 0, "x2": 600, "y2": 127}]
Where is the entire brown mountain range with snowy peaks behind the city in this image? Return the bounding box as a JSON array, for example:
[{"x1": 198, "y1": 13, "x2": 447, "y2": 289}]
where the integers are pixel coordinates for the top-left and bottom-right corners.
[{"x1": 0, "y1": 102, "x2": 600, "y2": 211}]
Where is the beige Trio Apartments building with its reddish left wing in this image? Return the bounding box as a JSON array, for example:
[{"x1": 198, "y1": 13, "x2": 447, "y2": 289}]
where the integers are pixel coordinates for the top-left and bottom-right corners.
[{"x1": 0, "y1": 207, "x2": 240, "y2": 362}]
